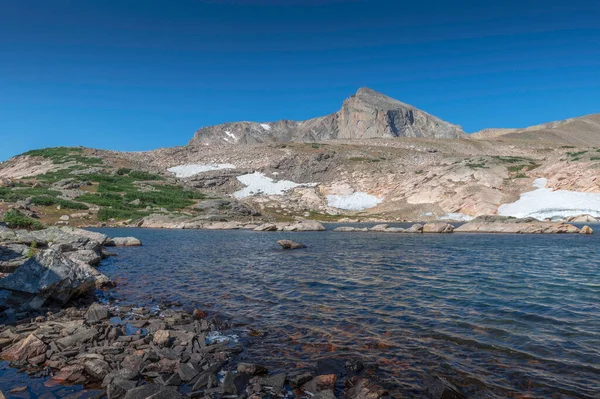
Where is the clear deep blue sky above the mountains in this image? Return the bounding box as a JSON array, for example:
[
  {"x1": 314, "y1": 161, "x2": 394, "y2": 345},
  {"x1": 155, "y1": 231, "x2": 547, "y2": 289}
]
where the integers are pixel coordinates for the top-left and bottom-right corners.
[{"x1": 0, "y1": 0, "x2": 600, "y2": 160}]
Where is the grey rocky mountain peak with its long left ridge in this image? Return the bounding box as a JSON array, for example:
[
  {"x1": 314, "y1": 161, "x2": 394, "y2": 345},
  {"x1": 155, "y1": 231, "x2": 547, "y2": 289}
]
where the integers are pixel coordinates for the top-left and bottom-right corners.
[{"x1": 189, "y1": 88, "x2": 465, "y2": 145}]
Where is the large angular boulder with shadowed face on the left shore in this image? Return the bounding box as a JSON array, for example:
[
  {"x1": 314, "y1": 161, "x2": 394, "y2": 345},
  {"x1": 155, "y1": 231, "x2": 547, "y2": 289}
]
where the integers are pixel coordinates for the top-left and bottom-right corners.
[{"x1": 0, "y1": 249, "x2": 109, "y2": 309}]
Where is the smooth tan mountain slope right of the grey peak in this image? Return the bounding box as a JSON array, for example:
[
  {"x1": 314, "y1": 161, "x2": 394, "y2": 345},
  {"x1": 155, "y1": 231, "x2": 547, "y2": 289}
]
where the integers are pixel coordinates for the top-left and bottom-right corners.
[{"x1": 471, "y1": 114, "x2": 600, "y2": 147}]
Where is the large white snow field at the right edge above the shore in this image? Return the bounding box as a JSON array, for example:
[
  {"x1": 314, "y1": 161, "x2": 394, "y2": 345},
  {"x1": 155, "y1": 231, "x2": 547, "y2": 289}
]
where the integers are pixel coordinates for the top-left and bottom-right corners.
[{"x1": 498, "y1": 178, "x2": 600, "y2": 220}]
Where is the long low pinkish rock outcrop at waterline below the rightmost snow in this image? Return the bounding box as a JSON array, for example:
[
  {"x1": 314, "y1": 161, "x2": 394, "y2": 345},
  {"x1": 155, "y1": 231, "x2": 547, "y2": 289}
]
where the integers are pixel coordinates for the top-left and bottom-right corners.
[{"x1": 454, "y1": 216, "x2": 579, "y2": 234}]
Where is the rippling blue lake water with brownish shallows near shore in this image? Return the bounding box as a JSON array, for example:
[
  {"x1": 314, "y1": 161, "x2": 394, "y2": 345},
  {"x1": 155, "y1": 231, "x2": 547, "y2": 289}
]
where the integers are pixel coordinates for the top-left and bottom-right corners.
[{"x1": 96, "y1": 226, "x2": 600, "y2": 398}]
